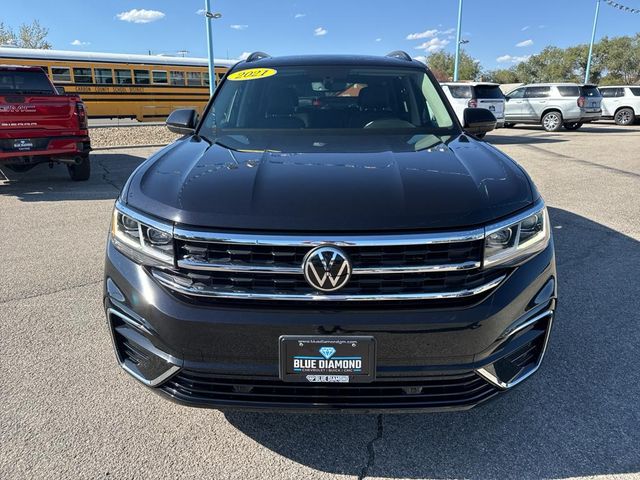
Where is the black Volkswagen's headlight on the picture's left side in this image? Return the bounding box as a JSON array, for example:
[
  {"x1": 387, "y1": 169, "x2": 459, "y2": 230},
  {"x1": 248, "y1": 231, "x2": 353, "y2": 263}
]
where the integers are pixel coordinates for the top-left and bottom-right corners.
[{"x1": 111, "y1": 204, "x2": 174, "y2": 265}]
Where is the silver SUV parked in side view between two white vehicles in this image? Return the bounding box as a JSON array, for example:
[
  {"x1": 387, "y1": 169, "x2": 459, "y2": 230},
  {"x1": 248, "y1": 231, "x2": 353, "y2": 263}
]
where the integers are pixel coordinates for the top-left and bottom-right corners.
[{"x1": 504, "y1": 83, "x2": 602, "y2": 132}]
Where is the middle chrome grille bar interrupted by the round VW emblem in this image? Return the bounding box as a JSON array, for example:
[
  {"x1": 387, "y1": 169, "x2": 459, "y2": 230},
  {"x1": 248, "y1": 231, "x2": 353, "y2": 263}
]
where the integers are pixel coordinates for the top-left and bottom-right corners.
[{"x1": 178, "y1": 259, "x2": 482, "y2": 275}]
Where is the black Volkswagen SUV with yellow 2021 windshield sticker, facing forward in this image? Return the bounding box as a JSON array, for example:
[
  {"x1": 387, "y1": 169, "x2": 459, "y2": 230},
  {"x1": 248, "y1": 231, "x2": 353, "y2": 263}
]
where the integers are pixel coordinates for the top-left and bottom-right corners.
[{"x1": 104, "y1": 52, "x2": 556, "y2": 411}]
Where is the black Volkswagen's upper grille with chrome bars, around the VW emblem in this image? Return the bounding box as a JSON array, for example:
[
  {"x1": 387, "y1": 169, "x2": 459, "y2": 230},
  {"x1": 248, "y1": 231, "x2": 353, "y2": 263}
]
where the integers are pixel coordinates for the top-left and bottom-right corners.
[{"x1": 152, "y1": 228, "x2": 507, "y2": 302}]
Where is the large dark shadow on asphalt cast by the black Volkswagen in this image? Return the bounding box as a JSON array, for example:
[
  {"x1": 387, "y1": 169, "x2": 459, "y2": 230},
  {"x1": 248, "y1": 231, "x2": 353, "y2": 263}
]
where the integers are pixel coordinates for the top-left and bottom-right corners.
[{"x1": 225, "y1": 208, "x2": 640, "y2": 479}]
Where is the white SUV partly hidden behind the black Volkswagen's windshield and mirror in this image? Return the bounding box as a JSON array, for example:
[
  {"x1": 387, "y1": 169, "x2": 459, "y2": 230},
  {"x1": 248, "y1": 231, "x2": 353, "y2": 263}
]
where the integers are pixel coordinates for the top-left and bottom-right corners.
[{"x1": 441, "y1": 82, "x2": 505, "y2": 134}]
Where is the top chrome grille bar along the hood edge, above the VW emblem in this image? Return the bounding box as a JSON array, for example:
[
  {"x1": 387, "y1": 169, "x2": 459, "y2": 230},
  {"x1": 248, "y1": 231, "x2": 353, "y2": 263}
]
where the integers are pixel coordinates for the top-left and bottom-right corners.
[{"x1": 174, "y1": 227, "x2": 484, "y2": 247}]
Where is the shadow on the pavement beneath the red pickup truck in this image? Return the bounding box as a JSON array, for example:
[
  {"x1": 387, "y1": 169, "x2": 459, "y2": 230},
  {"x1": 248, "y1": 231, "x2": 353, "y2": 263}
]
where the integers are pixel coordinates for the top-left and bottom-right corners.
[{"x1": 0, "y1": 151, "x2": 147, "y2": 202}]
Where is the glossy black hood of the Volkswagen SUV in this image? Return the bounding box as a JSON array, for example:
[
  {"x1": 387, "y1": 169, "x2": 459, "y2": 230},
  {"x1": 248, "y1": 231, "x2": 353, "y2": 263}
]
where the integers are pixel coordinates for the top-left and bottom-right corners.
[{"x1": 125, "y1": 133, "x2": 537, "y2": 232}]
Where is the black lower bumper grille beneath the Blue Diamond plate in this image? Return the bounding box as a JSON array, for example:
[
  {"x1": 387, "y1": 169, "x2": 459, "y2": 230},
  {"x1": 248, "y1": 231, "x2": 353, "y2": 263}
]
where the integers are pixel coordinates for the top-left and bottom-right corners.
[{"x1": 161, "y1": 370, "x2": 499, "y2": 409}]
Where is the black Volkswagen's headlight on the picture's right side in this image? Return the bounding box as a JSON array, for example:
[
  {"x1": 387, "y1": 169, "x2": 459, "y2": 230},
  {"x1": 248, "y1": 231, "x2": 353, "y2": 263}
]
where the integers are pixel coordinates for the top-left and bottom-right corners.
[{"x1": 484, "y1": 205, "x2": 551, "y2": 267}]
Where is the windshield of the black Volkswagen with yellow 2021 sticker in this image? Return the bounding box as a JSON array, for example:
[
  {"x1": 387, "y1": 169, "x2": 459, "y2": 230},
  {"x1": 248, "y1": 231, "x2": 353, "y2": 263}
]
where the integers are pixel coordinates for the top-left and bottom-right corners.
[{"x1": 200, "y1": 66, "x2": 457, "y2": 137}]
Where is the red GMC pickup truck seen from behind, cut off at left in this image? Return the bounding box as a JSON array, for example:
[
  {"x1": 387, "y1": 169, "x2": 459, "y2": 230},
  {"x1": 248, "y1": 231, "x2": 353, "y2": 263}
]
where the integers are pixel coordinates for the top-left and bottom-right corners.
[{"x1": 0, "y1": 65, "x2": 91, "y2": 180}]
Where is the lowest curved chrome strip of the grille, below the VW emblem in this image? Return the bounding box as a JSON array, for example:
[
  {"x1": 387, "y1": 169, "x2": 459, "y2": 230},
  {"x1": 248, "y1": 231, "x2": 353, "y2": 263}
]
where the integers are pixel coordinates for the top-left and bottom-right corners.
[{"x1": 152, "y1": 270, "x2": 506, "y2": 302}]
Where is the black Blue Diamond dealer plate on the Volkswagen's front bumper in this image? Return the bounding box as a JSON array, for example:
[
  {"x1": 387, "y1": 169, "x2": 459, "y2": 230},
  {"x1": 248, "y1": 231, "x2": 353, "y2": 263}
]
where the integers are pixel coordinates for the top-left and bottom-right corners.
[{"x1": 279, "y1": 335, "x2": 376, "y2": 384}]
